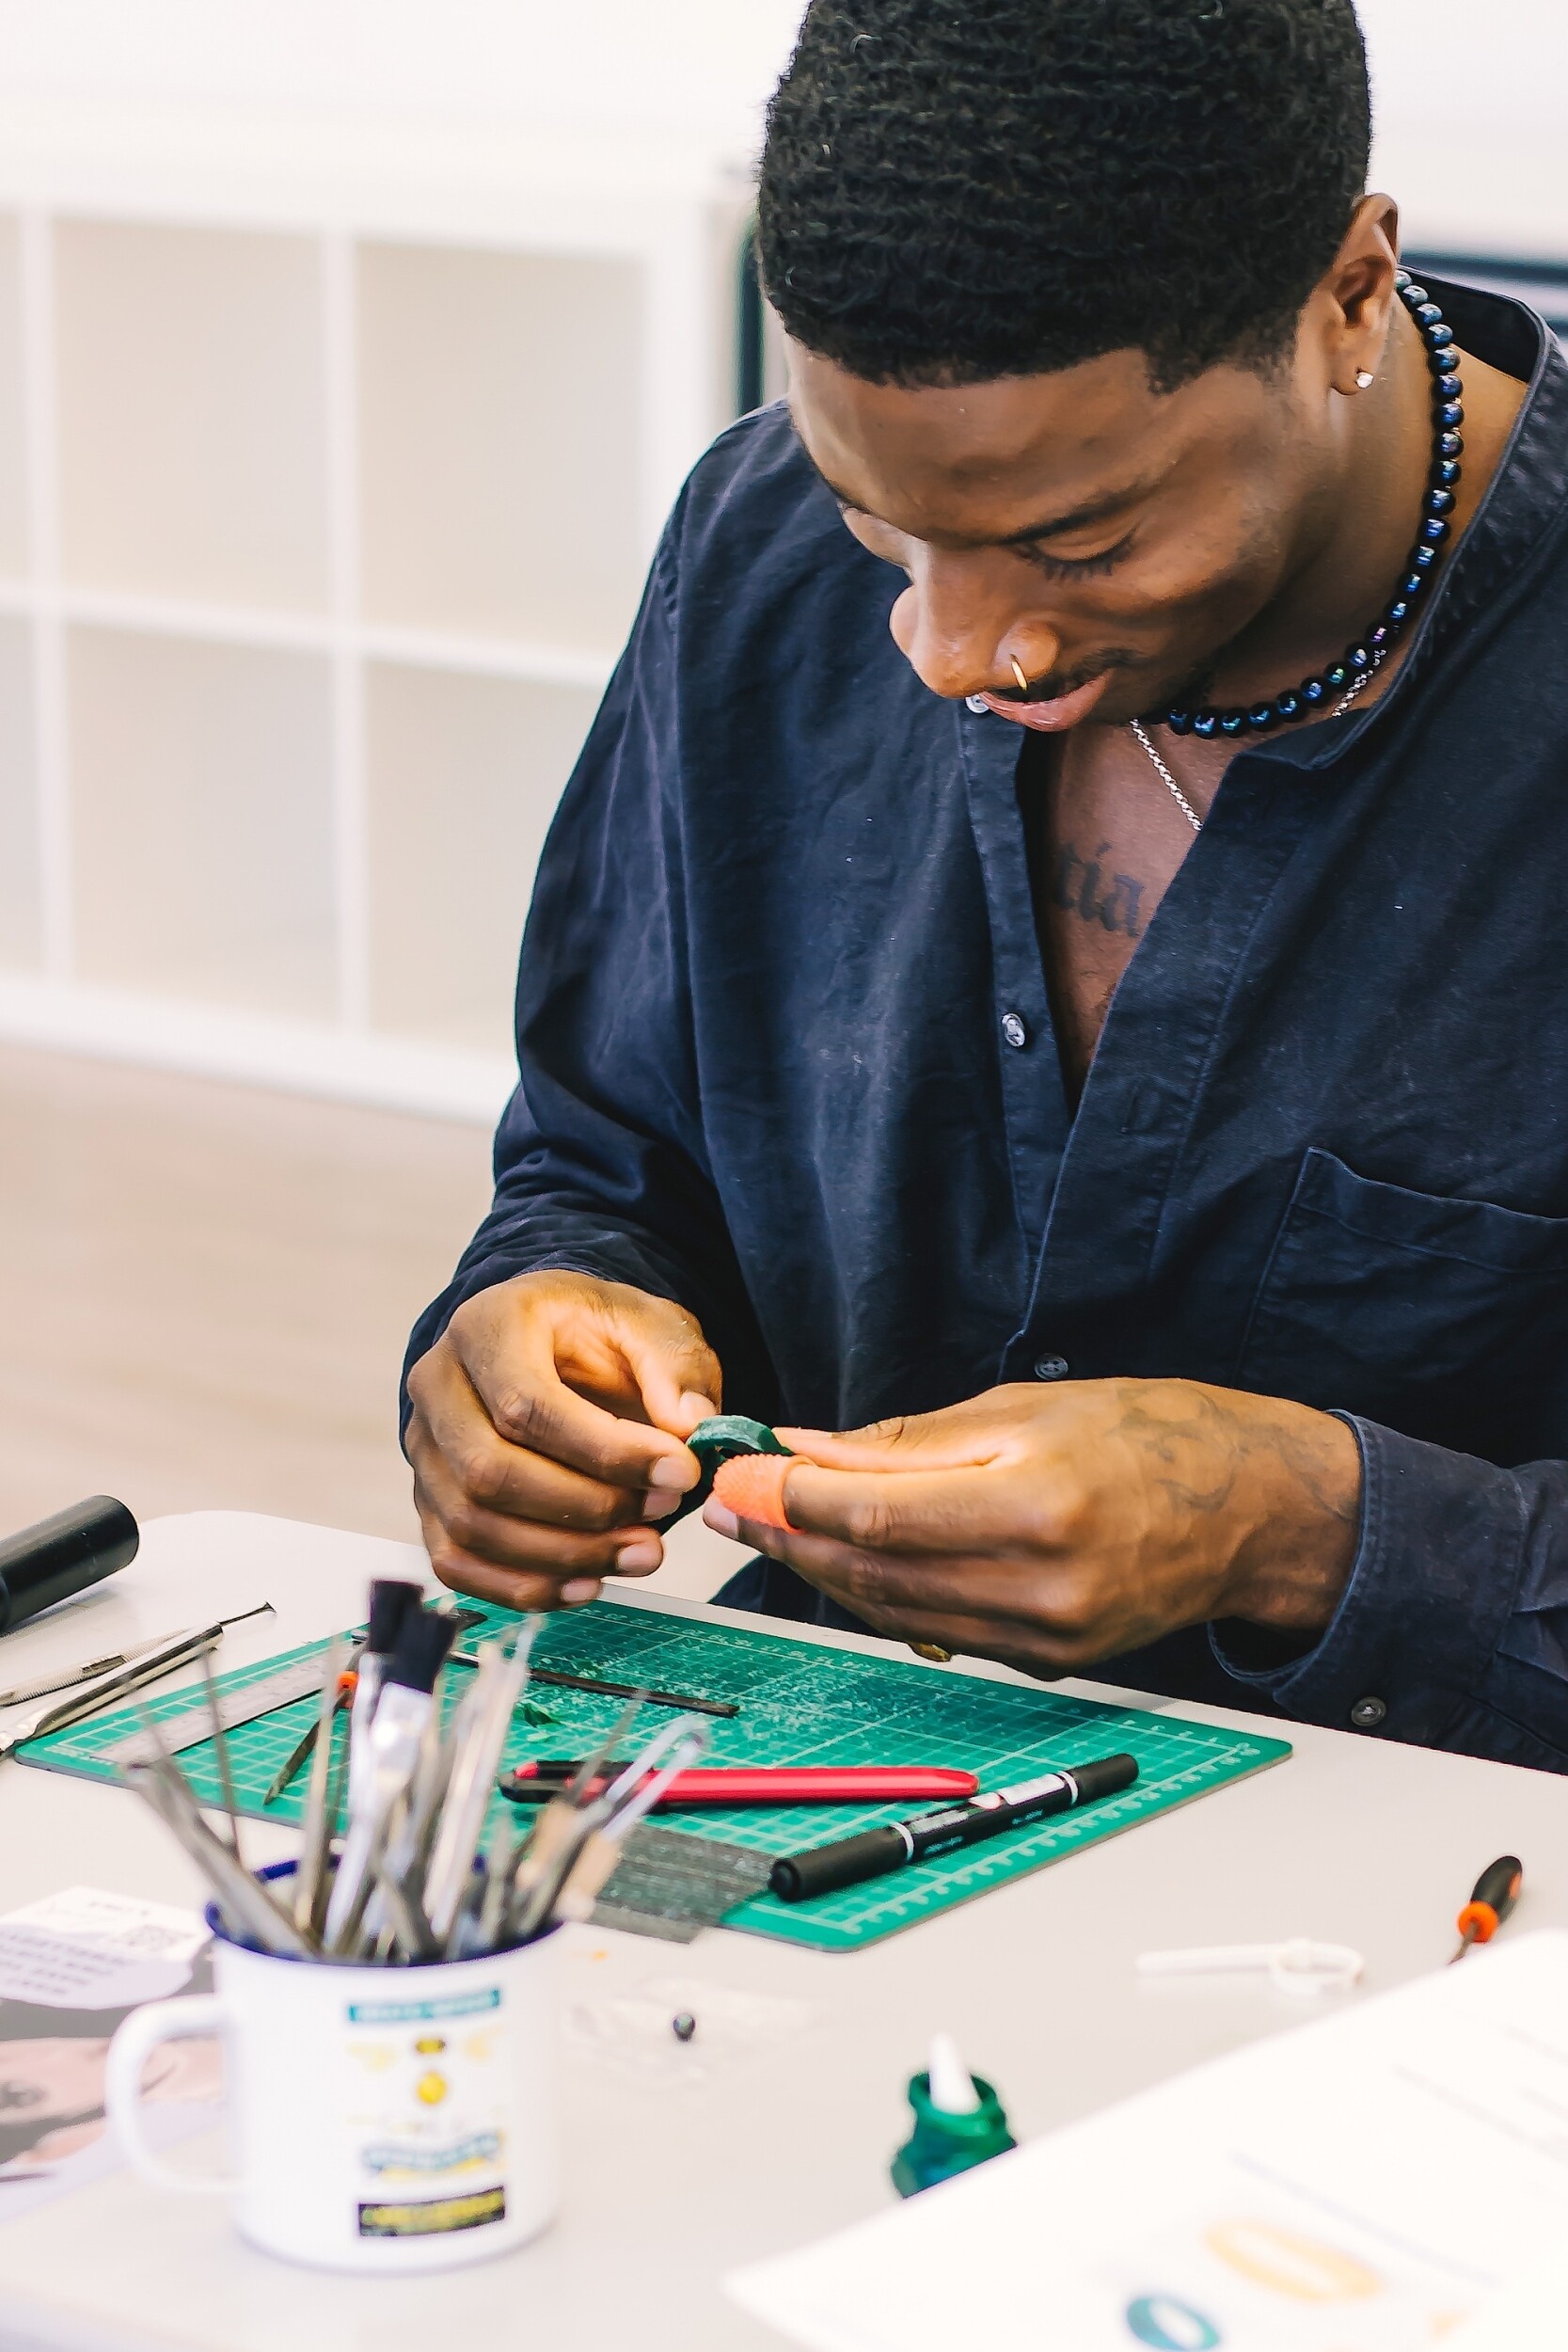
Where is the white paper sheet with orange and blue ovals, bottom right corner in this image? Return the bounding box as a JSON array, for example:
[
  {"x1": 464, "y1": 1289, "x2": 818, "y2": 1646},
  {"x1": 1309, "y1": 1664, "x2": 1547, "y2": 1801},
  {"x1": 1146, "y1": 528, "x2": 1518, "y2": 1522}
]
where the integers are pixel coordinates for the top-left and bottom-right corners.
[{"x1": 726, "y1": 1933, "x2": 1568, "y2": 2352}]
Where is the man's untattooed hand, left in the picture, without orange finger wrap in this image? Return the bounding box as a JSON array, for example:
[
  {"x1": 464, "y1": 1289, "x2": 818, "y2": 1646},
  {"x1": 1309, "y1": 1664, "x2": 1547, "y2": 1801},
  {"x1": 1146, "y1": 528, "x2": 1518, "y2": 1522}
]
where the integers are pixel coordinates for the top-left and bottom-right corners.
[{"x1": 404, "y1": 1273, "x2": 720, "y2": 1609}]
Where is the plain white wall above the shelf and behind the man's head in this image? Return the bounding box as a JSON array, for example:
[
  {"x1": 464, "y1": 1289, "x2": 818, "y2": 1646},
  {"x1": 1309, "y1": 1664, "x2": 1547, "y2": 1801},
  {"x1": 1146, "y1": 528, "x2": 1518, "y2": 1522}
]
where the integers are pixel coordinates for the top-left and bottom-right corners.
[{"x1": 0, "y1": 0, "x2": 1568, "y2": 259}]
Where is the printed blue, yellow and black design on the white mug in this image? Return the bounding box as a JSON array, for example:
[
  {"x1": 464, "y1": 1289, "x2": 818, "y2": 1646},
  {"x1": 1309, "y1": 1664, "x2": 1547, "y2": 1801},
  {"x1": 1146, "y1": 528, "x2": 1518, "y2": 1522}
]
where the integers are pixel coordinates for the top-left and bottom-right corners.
[{"x1": 343, "y1": 1985, "x2": 510, "y2": 2237}]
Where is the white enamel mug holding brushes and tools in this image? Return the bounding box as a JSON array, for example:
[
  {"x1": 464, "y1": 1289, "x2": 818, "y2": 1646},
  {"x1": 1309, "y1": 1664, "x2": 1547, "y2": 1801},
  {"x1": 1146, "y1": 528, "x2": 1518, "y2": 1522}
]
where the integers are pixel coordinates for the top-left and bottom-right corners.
[{"x1": 103, "y1": 1872, "x2": 560, "y2": 2272}]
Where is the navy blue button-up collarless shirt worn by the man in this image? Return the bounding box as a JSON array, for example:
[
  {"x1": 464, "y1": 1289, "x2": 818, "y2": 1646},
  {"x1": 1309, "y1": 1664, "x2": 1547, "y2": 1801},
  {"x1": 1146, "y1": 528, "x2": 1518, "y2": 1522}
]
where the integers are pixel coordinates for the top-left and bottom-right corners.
[{"x1": 411, "y1": 287, "x2": 1568, "y2": 1769}]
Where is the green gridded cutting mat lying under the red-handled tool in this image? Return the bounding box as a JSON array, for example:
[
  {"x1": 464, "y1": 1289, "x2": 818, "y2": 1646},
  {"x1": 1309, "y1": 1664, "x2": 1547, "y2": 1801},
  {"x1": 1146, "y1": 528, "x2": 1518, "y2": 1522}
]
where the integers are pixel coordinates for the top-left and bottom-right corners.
[{"x1": 19, "y1": 1602, "x2": 1291, "y2": 1952}]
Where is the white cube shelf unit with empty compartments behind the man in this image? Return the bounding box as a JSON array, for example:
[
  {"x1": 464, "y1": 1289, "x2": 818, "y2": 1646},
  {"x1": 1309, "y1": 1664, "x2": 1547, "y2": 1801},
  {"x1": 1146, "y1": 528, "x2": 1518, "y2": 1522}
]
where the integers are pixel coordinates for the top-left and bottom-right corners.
[{"x1": 0, "y1": 121, "x2": 745, "y2": 1118}]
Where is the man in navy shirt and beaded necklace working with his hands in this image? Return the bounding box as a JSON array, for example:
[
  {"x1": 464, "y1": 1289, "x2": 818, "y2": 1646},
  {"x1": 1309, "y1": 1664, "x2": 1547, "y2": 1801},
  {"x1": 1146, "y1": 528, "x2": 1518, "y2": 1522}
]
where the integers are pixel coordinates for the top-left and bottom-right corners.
[{"x1": 406, "y1": 0, "x2": 1568, "y2": 1769}]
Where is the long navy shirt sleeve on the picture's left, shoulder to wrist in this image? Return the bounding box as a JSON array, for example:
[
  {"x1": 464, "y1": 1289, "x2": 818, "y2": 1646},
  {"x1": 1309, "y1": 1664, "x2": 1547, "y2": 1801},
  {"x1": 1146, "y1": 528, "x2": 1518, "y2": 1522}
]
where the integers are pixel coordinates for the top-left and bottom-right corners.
[{"x1": 404, "y1": 508, "x2": 775, "y2": 1425}]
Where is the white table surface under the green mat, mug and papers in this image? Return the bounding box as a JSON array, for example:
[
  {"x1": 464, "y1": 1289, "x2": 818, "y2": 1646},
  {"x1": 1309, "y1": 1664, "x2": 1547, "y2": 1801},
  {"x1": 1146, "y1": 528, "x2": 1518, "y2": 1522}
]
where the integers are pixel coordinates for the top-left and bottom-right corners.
[{"x1": 0, "y1": 1513, "x2": 1568, "y2": 2352}]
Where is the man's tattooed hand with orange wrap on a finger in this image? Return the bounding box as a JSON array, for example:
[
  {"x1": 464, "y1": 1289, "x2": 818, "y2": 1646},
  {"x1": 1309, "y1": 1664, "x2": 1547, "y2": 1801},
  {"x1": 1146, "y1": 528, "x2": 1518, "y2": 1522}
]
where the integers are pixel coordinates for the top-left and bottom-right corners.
[{"x1": 705, "y1": 1381, "x2": 1361, "y2": 1675}]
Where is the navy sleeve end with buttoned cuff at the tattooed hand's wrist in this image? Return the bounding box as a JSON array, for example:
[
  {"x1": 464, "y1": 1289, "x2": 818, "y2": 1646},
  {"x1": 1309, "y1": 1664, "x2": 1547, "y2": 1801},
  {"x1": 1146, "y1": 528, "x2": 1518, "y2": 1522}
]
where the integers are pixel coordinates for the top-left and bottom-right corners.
[{"x1": 1213, "y1": 1414, "x2": 1568, "y2": 1772}]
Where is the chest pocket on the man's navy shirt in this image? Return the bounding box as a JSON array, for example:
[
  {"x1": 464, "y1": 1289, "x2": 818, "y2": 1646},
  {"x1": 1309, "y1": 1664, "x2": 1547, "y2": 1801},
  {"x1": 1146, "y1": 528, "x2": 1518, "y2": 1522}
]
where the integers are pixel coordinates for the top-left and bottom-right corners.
[{"x1": 1237, "y1": 1151, "x2": 1568, "y2": 1466}]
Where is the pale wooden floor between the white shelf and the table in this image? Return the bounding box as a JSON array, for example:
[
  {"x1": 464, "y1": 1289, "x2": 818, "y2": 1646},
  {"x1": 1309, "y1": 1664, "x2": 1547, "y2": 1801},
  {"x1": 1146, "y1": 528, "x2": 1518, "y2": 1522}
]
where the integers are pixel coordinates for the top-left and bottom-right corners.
[{"x1": 0, "y1": 1047, "x2": 740, "y2": 1595}]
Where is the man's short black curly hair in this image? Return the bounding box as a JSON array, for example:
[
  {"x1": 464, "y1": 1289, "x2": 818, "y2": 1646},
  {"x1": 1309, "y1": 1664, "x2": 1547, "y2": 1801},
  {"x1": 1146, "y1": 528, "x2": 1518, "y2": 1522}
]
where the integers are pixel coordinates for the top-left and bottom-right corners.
[{"x1": 757, "y1": 0, "x2": 1370, "y2": 390}]
